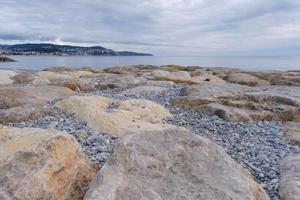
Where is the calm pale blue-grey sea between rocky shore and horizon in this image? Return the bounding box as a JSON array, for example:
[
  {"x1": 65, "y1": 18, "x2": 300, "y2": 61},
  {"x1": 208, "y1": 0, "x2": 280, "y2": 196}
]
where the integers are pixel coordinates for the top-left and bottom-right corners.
[{"x1": 0, "y1": 56, "x2": 300, "y2": 70}]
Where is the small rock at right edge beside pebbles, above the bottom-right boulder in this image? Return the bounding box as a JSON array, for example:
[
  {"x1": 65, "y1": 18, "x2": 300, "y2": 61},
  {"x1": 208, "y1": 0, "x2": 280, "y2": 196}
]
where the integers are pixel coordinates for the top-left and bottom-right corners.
[{"x1": 283, "y1": 122, "x2": 300, "y2": 144}]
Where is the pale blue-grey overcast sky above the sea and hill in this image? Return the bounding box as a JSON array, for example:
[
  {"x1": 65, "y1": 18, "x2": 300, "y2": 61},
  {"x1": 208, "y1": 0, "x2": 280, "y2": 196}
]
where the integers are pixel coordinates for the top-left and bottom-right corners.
[{"x1": 0, "y1": 0, "x2": 300, "y2": 56}]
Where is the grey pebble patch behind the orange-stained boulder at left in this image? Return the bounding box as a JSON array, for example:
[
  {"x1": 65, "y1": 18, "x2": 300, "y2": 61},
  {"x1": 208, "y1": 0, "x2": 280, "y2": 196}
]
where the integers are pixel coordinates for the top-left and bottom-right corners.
[{"x1": 8, "y1": 110, "x2": 117, "y2": 166}]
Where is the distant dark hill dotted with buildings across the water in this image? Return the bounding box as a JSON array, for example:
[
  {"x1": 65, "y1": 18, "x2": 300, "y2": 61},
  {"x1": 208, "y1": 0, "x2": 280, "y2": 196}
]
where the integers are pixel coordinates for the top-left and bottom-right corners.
[{"x1": 0, "y1": 43, "x2": 153, "y2": 56}]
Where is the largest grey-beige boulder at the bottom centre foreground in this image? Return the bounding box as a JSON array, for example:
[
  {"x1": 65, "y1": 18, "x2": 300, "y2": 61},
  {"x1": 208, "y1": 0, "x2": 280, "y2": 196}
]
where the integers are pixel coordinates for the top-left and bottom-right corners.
[{"x1": 84, "y1": 127, "x2": 269, "y2": 200}]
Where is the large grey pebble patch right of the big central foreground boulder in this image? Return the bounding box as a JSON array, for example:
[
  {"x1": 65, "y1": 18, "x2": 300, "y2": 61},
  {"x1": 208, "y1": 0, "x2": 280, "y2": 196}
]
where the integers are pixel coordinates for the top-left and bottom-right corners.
[{"x1": 166, "y1": 108, "x2": 300, "y2": 200}]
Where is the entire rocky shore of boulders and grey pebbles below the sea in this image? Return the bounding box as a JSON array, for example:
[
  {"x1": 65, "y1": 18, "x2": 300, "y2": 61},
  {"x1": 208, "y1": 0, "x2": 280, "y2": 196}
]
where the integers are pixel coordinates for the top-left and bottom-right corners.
[{"x1": 0, "y1": 65, "x2": 300, "y2": 200}]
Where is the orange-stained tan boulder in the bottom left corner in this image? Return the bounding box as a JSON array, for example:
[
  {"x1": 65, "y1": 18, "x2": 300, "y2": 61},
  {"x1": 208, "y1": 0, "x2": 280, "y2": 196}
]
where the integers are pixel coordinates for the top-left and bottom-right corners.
[{"x1": 0, "y1": 125, "x2": 97, "y2": 200}]
